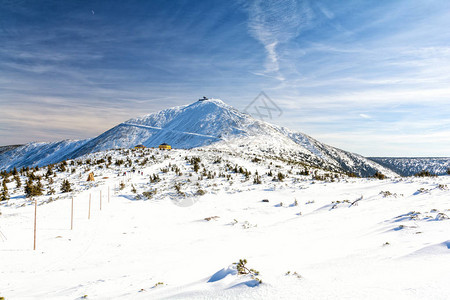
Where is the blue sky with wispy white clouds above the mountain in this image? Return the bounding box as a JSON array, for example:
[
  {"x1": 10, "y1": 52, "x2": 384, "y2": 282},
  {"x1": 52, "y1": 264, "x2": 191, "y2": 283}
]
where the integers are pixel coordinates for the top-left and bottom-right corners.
[{"x1": 0, "y1": 0, "x2": 450, "y2": 156}]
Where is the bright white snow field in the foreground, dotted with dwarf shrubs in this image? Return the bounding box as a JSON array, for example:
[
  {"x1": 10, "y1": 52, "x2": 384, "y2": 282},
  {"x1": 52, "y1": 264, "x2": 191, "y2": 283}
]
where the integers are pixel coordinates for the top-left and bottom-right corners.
[{"x1": 0, "y1": 150, "x2": 450, "y2": 299}]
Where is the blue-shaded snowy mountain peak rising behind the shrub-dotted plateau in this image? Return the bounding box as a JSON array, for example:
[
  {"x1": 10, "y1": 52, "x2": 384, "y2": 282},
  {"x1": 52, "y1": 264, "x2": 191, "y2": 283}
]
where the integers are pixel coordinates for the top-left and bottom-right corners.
[{"x1": 0, "y1": 99, "x2": 396, "y2": 176}]
